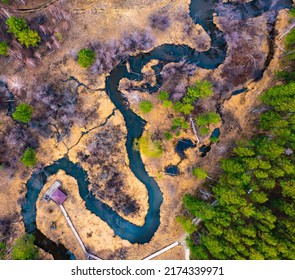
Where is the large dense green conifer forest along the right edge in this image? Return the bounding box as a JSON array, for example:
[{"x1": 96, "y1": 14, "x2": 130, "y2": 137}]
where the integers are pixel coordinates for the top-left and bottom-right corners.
[{"x1": 178, "y1": 77, "x2": 295, "y2": 259}]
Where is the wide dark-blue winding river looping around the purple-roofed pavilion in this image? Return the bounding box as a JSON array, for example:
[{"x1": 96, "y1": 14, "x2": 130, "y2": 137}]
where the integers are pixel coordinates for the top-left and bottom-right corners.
[{"x1": 22, "y1": 0, "x2": 291, "y2": 259}]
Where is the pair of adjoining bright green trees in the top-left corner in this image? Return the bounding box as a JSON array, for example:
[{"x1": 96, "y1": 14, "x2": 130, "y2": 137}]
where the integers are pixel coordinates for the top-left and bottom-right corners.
[{"x1": 6, "y1": 16, "x2": 41, "y2": 48}]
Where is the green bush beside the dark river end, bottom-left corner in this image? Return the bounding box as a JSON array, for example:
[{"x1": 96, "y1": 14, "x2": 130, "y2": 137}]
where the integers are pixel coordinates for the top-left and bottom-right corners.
[{"x1": 11, "y1": 234, "x2": 38, "y2": 260}]
